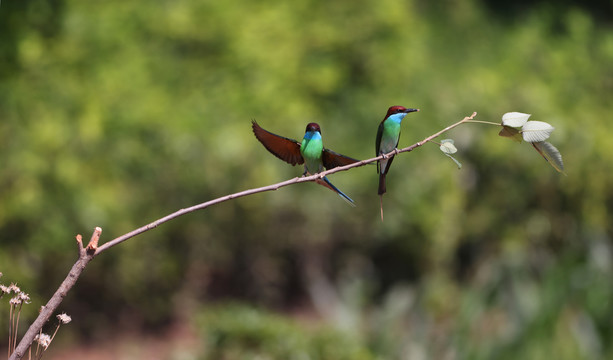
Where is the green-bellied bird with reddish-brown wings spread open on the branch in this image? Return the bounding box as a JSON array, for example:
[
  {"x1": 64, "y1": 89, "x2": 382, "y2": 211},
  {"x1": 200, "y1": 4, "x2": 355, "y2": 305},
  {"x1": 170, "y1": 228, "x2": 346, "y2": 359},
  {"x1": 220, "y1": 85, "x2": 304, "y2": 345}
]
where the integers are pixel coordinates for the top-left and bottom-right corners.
[{"x1": 251, "y1": 120, "x2": 359, "y2": 206}]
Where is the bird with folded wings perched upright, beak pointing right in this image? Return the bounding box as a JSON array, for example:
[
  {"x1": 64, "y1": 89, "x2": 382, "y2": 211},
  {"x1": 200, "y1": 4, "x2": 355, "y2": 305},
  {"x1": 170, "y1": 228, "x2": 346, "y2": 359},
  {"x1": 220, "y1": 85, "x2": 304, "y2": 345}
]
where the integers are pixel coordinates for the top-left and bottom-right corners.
[{"x1": 375, "y1": 106, "x2": 419, "y2": 220}]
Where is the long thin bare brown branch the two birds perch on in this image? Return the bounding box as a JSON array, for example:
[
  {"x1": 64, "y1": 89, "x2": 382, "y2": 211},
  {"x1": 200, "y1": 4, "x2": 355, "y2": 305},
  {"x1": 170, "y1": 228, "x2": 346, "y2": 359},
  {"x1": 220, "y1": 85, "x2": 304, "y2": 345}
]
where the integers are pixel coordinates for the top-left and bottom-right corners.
[{"x1": 9, "y1": 112, "x2": 477, "y2": 360}]
